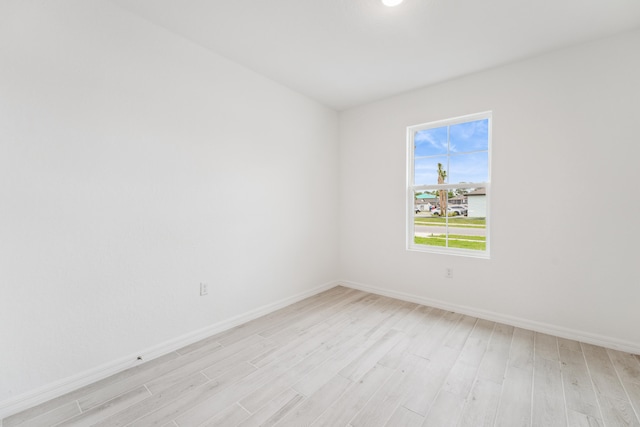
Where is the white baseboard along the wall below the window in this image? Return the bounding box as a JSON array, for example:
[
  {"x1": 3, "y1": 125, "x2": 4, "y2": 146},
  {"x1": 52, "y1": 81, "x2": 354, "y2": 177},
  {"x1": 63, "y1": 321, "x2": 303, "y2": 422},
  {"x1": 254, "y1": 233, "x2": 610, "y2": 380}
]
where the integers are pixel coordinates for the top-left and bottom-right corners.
[{"x1": 337, "y1": 280, "x2": 640, "y2": 354}]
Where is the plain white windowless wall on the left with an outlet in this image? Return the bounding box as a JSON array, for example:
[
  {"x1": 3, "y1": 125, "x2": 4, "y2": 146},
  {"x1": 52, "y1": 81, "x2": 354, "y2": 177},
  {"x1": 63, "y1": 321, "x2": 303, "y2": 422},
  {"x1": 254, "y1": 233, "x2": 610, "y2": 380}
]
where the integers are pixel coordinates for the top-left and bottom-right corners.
[{"x1": 0, "y1": 0, "x2": 338, "y2": 406}]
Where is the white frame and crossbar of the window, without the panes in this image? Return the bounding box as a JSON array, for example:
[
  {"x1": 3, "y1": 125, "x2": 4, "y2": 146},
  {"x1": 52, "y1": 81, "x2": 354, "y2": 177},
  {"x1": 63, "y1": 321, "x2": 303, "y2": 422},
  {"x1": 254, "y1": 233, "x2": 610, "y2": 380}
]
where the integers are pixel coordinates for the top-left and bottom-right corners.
[{"x1": 406, "y1": 111, "x2": 493, "y2": 259}]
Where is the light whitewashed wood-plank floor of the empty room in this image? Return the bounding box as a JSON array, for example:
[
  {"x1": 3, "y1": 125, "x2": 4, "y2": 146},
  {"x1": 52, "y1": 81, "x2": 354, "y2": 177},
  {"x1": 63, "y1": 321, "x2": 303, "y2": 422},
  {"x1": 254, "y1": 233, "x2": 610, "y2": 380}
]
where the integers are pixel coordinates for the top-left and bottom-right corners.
[{"x1": 3, "y1": 287, "x2": 640, "y2": 427}]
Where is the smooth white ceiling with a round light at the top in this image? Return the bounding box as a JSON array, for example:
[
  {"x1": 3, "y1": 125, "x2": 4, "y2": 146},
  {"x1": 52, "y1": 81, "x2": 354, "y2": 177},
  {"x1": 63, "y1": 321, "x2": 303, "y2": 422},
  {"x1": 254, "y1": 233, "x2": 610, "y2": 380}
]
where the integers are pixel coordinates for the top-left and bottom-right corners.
[{"x1": 111, "y1": 0, "x2": 640, "y2": 110}]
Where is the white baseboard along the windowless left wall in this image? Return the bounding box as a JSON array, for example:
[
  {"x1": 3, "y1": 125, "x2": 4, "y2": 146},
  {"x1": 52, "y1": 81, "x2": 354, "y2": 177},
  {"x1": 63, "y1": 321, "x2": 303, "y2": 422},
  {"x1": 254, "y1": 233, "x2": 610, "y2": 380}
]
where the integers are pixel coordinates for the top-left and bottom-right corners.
[{"x1": 0, "y1": 281, "x2": 339, "y2": 426}]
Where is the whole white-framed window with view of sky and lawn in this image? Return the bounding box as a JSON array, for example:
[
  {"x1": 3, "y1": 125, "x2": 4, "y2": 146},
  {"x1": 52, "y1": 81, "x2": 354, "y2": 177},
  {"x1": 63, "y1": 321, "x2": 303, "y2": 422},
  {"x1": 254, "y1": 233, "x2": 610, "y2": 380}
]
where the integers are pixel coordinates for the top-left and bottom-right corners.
[{"x1": 407, "y1": 112, "x2": 491, "y2": 258}]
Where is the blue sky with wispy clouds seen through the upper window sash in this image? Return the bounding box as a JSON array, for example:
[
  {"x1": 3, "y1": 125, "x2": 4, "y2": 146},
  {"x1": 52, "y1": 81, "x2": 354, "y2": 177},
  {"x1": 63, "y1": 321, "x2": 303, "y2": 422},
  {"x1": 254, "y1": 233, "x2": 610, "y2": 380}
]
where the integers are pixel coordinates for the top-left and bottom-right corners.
[{"x1": 414, "y1": 119, "x2": 489, "y2": 185}]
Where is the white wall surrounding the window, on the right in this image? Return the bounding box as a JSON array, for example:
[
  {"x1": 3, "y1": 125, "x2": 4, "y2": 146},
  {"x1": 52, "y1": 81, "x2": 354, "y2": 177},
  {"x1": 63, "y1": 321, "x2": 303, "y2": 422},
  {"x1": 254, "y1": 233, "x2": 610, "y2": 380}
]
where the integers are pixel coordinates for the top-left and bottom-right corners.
[{"x1": 340, "y1": 31, "x2": 640, "y2": 351}]
